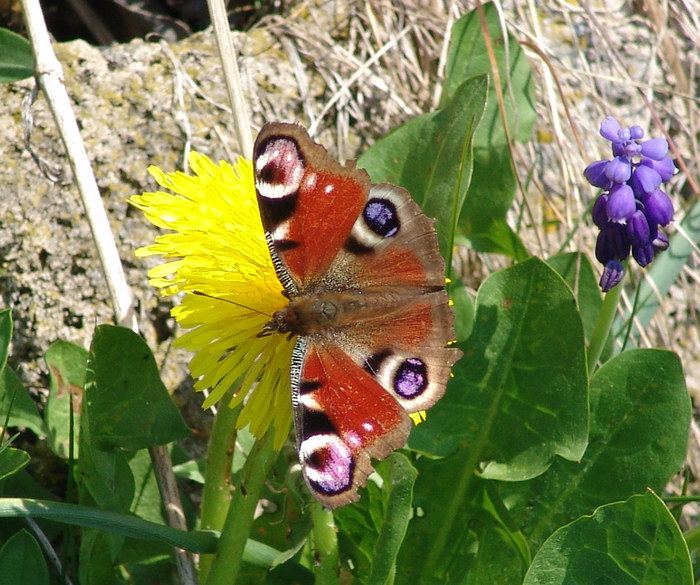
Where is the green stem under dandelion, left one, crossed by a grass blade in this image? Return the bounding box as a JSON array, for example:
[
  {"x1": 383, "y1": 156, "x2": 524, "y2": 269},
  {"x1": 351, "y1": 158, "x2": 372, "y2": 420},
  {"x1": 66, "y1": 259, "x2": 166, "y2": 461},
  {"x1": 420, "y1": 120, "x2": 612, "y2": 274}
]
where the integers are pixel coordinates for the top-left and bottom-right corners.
[{"x1": 199, "y1": 388, "x2": 242, "y2": 583}]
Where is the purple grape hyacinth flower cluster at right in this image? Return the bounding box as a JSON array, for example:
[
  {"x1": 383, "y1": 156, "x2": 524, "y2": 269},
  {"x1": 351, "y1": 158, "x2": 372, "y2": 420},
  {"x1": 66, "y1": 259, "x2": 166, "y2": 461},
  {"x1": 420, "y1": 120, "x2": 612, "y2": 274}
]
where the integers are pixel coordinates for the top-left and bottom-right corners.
[{"x1": 583, "y1": 116, "x2": 676, "y2": 292}]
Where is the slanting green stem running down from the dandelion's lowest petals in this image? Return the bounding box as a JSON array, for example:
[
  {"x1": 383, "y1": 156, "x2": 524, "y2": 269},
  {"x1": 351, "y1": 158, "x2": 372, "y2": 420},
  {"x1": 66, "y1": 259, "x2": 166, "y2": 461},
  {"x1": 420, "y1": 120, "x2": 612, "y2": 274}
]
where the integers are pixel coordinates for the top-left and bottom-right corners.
[{"x1": 206, "y1": 429, "x2": 276, "y2": 585}]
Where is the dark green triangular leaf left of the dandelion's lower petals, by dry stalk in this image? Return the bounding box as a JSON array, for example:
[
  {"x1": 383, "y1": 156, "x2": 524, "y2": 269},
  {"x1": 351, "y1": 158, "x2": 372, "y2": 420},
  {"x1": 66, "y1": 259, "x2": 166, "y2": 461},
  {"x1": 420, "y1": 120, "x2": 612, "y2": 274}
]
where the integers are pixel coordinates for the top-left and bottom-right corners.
[{"x1": 85, "y1": 325, "x2": 190, "y2": 449}]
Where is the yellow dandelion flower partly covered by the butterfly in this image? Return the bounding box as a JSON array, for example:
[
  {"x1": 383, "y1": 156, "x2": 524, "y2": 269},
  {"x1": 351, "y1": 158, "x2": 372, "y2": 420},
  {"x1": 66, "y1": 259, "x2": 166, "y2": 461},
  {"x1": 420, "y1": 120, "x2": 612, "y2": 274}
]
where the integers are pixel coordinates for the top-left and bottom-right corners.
[{"x1": 129, "y1": 152, "x2": 294, "y2": 448}]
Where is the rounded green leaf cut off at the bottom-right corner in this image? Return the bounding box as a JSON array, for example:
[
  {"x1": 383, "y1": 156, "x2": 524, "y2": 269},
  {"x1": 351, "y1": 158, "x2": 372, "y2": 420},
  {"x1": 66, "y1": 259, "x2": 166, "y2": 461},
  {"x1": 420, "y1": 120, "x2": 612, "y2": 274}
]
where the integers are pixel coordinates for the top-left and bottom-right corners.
[{"x1": 523, "y1": 493, "x2": 694, "y2": 585}]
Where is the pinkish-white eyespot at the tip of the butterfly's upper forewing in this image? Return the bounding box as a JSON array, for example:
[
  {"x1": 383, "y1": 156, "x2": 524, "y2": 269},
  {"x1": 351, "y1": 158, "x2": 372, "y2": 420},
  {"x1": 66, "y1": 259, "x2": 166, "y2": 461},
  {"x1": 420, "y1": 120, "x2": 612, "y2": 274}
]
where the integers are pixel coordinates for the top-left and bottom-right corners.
[{"x1": 255, "y1": 138, "x2": 306, "y2": 199}]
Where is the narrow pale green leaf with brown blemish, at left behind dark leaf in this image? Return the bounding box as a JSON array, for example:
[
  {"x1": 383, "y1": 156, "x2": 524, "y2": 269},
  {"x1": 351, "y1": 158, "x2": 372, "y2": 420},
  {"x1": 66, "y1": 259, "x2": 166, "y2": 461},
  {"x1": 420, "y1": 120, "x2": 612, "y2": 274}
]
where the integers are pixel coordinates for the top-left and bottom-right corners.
[{"x1": 44, "y1": 341, "x2": 88, "y2": 459}]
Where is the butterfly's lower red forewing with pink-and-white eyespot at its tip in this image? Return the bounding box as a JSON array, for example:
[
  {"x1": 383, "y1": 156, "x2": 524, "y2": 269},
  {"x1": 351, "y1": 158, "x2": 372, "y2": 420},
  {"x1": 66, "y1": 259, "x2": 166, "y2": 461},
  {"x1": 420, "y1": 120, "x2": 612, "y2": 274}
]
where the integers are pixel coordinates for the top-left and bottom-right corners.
[{"x1": 292, "y1": 337, "x2": 411, "y2": 508}]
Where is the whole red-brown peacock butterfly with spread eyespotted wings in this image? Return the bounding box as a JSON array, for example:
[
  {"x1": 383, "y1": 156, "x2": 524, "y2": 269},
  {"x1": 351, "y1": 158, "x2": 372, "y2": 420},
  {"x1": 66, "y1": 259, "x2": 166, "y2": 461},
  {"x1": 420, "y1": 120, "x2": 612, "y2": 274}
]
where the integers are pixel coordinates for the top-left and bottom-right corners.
[{"x1": 253, "y1": 123, "x2": 462, "y2": 508}]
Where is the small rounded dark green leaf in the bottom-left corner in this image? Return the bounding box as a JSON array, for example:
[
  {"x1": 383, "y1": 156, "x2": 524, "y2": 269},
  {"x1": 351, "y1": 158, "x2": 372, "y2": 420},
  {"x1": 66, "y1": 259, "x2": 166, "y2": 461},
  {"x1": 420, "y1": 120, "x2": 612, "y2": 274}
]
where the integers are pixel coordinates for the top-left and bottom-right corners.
[{"x1": 0, "y1": 530, "x2": 49, "y2": 585}]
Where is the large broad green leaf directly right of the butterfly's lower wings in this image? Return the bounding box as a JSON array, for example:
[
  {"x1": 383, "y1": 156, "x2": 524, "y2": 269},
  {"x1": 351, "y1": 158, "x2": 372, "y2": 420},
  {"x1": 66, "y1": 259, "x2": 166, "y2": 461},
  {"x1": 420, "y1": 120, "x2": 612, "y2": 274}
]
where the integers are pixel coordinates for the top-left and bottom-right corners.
[{"x1": 409, "y1": 259, "x2": 588, "y2": 474}]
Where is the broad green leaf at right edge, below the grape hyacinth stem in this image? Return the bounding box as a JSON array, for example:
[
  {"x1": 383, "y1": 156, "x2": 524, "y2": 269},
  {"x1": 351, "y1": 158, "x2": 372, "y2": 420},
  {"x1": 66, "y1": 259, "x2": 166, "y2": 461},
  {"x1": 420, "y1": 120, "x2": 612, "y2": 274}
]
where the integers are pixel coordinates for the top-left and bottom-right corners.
[{"x1": 501, "y1": 349, "x2": 690, "y2": 544}]
